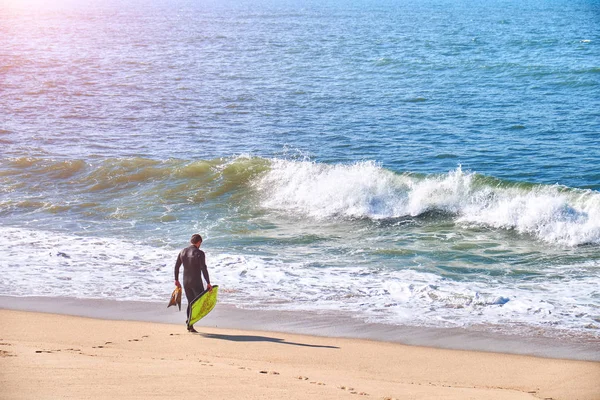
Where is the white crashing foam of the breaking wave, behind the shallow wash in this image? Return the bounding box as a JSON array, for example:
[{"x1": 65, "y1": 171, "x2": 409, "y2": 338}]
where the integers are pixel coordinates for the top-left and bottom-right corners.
[{"x1": 255, "y1": 160, "x2": 600, "y2": 246}]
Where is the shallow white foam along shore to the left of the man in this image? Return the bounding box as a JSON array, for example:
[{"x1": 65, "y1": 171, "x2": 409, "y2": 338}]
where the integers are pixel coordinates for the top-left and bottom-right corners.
[{"x1": 0, "y1": 227, "x2": 172, "y2": 300}]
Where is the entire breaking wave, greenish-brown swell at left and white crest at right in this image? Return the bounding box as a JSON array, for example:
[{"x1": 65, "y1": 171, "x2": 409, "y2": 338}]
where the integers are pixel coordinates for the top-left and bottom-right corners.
[{"x1": 0, "y1": 156, "x2": 600, "y2": 246}]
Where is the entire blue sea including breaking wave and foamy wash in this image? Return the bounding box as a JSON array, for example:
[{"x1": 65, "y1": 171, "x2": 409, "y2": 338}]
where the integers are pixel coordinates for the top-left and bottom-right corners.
[{"x1": 0, "y1": 0, "x2": 600, "y2": 340}]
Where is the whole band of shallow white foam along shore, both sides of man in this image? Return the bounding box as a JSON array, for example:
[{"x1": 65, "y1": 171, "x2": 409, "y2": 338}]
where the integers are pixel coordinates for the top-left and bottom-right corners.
[{"x1": 0, "y1": 227, "x2": 600, "y2": 335}]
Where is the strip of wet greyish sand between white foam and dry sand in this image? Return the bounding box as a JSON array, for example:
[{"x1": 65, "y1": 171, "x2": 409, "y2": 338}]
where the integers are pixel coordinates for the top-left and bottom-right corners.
[{"x1": 0, "y1": 296, "x2": 600, "y2": 362}]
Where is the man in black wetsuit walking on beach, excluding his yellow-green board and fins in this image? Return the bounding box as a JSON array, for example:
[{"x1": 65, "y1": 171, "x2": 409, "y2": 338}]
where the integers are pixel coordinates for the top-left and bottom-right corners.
[{"x1": 175, "y1": 233, "x2": 212, "y2": 332}]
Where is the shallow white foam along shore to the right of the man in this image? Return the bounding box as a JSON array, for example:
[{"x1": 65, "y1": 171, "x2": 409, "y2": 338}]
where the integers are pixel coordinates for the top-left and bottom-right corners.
[{"x1": 206, "y1": 252, "x2": 600, "y2": 334}]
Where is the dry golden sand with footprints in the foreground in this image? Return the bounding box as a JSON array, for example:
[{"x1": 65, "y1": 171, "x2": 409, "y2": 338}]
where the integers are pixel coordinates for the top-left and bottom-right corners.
[{"x1": 0, "y1": 310, "x2": 600, "y2": 400}]
